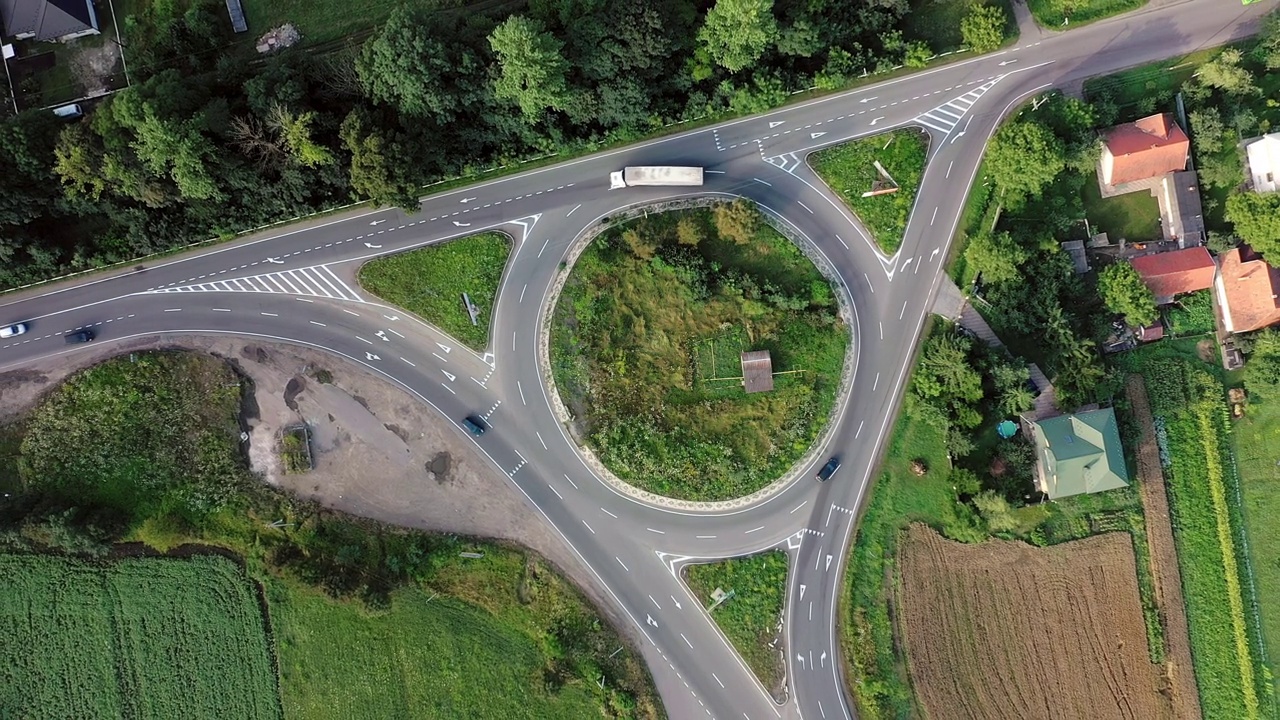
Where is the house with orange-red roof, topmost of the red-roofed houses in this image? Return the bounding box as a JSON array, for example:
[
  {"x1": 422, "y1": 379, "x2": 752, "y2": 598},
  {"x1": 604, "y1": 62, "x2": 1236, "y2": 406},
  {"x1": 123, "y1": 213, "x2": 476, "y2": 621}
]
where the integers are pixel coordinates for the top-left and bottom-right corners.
[{"x1": 1100, "y1": 113, "x2": 1192, "y2": 188}]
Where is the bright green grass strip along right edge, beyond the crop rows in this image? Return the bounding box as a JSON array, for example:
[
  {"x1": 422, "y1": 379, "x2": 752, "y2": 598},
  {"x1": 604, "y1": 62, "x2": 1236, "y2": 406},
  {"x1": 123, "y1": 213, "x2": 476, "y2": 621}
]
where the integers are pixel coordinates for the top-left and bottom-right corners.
[{"x1": 1231, "y1": 386, "x2": 1280, "y2": 707}]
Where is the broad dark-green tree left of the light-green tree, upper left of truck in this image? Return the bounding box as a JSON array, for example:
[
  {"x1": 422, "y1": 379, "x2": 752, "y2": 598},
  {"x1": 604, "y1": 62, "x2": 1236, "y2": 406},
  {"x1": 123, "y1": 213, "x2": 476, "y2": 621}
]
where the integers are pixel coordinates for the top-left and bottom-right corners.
[{"x1": 356, "y1": 5, "x2": 485, "y2": 124}]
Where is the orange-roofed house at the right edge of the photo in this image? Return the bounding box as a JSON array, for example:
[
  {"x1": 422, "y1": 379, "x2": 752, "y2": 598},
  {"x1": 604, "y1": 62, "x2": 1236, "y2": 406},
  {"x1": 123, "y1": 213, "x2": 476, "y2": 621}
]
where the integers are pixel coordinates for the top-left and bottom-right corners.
[{"x1": 1215, "y1": 245, "x2": 1280, "y2": 333}]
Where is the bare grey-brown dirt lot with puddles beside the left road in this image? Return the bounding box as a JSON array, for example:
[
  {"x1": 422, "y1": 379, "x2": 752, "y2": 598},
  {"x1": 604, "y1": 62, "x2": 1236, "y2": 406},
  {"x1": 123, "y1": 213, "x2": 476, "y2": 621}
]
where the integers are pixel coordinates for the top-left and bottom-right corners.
[{"x1": 0, "y1": 337, "x2": 614, "y2": 622}]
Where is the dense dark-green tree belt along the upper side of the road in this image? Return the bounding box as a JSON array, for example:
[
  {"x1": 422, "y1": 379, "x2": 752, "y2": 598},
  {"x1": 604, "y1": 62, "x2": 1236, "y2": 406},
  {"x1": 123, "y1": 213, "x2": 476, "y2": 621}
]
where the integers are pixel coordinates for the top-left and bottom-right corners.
[{"x1": 0, "y1": 0, "x2": 929, "y2": 287}]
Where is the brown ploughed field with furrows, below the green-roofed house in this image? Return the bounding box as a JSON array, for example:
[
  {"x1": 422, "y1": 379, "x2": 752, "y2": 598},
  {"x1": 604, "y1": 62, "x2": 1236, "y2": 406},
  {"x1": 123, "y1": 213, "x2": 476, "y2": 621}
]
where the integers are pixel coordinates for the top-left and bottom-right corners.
[{"x1": 899, "y1": 524, "x2": 1174, "y2": 720}]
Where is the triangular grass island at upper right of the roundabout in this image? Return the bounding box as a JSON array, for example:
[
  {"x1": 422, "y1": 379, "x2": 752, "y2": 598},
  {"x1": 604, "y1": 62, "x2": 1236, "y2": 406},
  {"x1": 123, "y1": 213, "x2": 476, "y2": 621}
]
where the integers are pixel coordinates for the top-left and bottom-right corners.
[{"x1": 809, "y1": 129, "x2": 929, "y2": 255}]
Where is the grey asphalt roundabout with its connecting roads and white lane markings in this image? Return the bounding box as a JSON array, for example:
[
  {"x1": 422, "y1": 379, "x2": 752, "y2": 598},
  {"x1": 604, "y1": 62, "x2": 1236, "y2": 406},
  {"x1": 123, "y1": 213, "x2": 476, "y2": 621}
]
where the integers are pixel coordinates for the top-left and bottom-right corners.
[{"x1": 0, "y1": 0, "x2": 1275, "y2": 719}]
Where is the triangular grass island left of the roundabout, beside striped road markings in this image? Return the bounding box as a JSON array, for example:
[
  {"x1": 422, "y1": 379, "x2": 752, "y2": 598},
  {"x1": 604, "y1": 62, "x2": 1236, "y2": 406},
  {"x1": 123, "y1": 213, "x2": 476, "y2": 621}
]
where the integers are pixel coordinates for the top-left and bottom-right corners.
[{"x1": 358, "y1": 232, "x2": 511, "y2": 352}]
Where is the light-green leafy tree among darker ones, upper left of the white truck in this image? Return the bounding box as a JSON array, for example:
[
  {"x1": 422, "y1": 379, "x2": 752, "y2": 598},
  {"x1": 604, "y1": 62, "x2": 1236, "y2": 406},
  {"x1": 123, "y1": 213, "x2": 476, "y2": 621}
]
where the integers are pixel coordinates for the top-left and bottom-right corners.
[{"x1": 489, "y1": 15, "x2": 570, "y2": 119}]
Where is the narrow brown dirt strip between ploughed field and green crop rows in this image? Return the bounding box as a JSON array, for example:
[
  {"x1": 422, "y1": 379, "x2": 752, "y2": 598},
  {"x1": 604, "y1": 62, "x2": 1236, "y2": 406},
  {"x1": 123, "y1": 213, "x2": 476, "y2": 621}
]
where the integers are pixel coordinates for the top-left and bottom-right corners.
[{"x1": 1125, "y1": 375, "x2": 1201, "y2": 719}]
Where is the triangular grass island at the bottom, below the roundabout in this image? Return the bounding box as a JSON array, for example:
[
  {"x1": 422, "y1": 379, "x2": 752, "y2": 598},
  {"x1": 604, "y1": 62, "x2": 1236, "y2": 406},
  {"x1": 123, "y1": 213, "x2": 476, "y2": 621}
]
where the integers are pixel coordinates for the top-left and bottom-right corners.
[{"x1": 685, "y1": 550, "x2": 787, "y2": 692}]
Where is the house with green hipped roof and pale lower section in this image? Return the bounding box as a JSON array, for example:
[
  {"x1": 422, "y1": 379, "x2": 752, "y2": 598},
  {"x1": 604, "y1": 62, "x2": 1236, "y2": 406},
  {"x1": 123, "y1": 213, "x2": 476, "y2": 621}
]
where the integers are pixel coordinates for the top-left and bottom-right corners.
[{"x1": 1027, "y1": 407, "x2": 1129, "y2": 500}]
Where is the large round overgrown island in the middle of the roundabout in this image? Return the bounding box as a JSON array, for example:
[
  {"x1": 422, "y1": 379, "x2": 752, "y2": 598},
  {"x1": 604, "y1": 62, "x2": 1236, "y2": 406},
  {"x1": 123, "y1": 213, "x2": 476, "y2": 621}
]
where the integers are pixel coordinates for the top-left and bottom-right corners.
[{"x1": 550, "y1": 200, "x2": 849, "y2": 501}]
